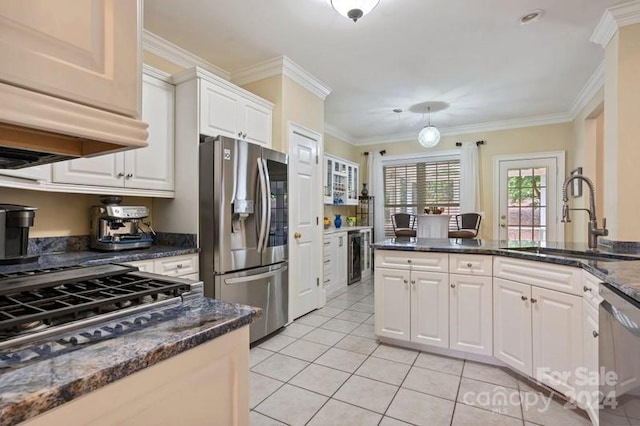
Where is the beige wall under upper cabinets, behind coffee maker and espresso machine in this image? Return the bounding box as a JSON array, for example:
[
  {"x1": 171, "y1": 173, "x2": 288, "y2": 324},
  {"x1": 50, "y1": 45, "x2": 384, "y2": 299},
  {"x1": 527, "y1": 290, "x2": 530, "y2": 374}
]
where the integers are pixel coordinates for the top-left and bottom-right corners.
[{"x1": 0, "y1": 188, "x2": 153, "y2": 238}]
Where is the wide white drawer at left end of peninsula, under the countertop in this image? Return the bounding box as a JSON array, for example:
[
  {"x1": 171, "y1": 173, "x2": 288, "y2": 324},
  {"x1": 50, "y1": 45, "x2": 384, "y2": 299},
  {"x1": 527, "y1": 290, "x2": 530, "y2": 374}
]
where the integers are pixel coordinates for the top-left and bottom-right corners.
[{"x1": 375, "y1": 250, "x2": 449, "y2": 272}]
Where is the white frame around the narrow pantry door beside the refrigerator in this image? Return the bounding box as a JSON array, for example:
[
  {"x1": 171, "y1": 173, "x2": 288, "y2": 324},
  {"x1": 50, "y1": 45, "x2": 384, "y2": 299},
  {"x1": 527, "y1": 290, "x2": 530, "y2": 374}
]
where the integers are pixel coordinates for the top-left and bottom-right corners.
[{"x1": 287, "y1": 121, "x2": 327, "y2": 321}]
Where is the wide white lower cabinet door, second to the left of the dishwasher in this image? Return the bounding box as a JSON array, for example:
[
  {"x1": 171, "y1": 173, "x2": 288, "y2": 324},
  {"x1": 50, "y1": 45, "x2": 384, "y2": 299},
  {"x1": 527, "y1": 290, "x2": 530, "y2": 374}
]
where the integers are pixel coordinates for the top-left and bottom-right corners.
[{"x1": 531, "y1": 287, "x2": 583, "y2": 396}]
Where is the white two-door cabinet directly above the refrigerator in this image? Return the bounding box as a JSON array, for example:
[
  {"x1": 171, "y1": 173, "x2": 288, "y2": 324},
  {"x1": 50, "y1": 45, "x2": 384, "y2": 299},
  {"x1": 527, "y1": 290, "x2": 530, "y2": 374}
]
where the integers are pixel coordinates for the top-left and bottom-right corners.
[{"x1": 200, "y1": 76, "x2": 273, "y2": 146}]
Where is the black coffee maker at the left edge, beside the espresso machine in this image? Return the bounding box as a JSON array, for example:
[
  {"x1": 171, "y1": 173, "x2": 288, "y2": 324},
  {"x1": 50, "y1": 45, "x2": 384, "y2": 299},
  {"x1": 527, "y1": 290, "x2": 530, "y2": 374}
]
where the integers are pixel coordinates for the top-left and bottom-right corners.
[{"x1": 0, "y1": 204, "x2": 38, "y2": 265}]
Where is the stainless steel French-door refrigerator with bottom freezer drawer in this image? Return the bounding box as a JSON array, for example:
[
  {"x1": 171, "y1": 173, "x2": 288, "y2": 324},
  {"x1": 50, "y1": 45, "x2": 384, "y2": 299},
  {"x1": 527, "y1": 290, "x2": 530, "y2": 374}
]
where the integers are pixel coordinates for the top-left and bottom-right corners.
[{"x1": 199, "y1": 136, "x2": 289, "y2": 342}]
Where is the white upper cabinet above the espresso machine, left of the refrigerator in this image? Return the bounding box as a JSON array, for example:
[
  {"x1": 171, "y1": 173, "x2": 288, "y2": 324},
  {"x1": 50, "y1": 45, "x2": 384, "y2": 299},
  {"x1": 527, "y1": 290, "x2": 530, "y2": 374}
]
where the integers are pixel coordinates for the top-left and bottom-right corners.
[{"x1": 52, "y1": 71, "x2": 174, "y2": 195}]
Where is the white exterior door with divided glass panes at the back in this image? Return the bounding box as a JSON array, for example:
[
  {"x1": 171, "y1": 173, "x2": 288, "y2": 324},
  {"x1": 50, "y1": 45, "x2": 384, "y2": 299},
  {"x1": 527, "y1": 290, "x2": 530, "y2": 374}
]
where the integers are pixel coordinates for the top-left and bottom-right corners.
[{"x1": 493, "y1": 152, "x2": 564, "y2": 241}]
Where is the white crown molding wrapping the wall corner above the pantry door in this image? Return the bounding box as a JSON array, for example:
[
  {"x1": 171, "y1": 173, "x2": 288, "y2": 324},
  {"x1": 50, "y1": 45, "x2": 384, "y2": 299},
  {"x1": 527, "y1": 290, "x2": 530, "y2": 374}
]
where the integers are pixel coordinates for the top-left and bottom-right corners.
[{"x1": 231, "y1": 56, "x2": 331, "y2": 101}]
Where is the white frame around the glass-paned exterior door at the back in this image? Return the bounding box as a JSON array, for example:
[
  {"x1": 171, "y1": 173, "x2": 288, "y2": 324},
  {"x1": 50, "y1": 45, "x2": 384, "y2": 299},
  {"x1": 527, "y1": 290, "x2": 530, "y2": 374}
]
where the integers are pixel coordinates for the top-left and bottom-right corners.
[{"x1": 493, "y1": 151, "x2": 566, "y2": 242}]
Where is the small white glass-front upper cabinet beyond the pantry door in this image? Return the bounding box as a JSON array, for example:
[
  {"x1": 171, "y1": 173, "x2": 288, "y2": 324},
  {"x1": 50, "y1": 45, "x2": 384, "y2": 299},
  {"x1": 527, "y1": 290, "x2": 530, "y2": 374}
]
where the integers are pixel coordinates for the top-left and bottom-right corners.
[{"x1": 324, "y1": 155, "x2": 360, "y2": 206}]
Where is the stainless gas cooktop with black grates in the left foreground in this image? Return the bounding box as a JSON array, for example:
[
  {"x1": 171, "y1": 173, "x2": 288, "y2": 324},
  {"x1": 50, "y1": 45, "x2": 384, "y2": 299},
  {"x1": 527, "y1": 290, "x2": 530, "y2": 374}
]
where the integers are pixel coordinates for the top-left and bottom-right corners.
[{"x1": 0, "y1": 264, "x2": 202, "y2": 370}]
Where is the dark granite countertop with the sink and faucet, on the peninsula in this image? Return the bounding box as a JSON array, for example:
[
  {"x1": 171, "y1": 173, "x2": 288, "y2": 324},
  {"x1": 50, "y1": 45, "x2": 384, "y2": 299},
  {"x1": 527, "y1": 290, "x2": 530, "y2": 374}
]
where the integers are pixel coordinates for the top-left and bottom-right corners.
[{"x1": 372, "y1": 238, "x2": 640, "y2": 303}]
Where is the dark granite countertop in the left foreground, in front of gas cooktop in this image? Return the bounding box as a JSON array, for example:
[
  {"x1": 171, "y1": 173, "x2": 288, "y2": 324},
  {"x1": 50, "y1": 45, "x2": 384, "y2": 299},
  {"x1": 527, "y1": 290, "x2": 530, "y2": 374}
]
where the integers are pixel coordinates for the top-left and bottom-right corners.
[{"x1": 0, "y1": 294, "x2": 262, "y2": 426}]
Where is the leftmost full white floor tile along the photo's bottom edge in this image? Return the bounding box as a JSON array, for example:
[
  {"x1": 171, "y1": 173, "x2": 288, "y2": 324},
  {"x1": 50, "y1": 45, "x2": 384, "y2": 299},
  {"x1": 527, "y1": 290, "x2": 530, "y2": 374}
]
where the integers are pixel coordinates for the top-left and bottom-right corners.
[{"x1": 255, "y1": 384, "x2": 328, "y2": 426}]
